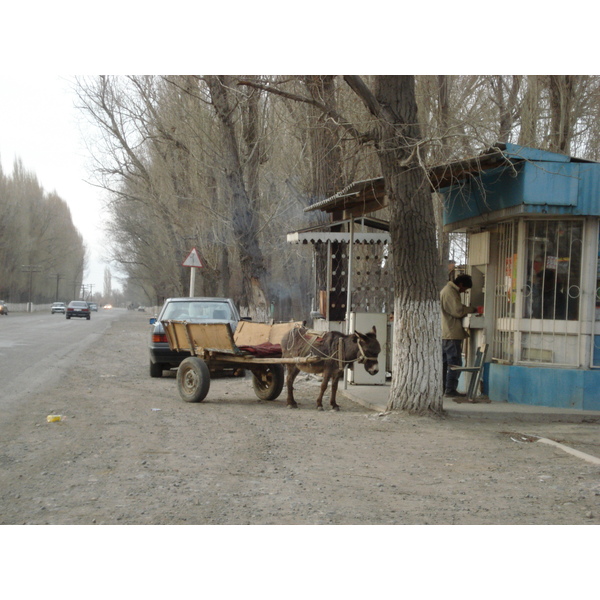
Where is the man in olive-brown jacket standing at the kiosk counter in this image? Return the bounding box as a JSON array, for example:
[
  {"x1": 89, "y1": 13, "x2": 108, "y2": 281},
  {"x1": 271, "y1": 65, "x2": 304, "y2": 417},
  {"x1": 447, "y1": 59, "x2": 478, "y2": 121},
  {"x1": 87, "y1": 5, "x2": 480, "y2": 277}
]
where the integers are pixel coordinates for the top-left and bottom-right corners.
[{"x1": 440, "y1": 275, "x2": 477, "y2": 398}]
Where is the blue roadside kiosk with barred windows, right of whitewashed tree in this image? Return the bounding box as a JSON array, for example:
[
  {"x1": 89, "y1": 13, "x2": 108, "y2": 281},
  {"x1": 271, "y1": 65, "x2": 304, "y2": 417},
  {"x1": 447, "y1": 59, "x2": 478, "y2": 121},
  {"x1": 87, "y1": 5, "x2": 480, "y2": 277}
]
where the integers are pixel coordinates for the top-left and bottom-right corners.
[{"x1": 431, "y1": 144, "x2": 600, "y2": 410}]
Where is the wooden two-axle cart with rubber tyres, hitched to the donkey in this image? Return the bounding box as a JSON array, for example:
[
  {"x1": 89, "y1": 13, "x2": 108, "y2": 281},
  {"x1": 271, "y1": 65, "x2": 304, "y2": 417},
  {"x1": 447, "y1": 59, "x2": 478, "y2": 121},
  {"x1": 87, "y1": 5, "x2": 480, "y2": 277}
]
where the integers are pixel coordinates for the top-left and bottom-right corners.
[{"x1": 162, "y1": 321, "x2": 319, "y2": 402}]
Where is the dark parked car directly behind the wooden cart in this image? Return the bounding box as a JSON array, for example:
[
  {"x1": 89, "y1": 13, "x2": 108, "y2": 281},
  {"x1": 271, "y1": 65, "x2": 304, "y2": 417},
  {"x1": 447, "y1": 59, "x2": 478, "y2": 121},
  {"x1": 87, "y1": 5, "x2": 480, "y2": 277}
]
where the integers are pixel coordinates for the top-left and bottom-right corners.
[{"x1": 149, "y1": 298, "x2": 245, "y2": 377}]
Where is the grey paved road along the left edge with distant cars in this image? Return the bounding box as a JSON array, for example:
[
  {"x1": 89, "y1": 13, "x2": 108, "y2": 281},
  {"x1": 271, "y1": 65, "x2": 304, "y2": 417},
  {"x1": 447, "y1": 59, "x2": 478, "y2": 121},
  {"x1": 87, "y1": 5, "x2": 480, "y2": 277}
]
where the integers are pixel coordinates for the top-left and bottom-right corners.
[{"x1": 0, "y1": 309, "x2": 125, "y2": 411}]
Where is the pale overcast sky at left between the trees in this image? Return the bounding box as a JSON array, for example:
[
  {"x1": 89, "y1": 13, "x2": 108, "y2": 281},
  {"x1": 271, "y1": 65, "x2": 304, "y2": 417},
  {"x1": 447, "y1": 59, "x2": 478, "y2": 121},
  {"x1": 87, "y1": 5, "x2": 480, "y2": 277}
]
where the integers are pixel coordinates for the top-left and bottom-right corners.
[{"x1": 0, "y1": 72, "x2": 111, "y2": 292}]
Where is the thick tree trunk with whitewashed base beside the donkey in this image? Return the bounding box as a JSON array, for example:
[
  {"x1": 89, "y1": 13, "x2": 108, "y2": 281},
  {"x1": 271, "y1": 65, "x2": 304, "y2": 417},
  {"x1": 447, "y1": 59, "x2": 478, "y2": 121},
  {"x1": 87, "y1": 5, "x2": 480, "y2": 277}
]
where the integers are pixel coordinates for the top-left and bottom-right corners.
[{"x1": 347, "y1": 76, "x2": 443, "y2": 414}]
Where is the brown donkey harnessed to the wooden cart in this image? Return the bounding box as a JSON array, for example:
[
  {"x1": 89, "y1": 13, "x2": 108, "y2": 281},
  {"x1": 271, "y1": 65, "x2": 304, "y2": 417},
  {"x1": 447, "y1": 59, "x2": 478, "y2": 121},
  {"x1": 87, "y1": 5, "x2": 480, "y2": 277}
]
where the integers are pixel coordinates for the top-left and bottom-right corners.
[{"x1": 281, "y1": 327, "x2": 381, "y2": 410}]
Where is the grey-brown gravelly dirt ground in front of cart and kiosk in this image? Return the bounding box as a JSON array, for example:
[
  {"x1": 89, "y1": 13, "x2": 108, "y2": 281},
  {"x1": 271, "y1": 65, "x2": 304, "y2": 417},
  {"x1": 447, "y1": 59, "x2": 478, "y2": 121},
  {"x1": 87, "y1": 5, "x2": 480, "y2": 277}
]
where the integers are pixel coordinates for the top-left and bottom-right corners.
[{"x1": 0, "y1": 312, "x2": 600, "y2": 525}]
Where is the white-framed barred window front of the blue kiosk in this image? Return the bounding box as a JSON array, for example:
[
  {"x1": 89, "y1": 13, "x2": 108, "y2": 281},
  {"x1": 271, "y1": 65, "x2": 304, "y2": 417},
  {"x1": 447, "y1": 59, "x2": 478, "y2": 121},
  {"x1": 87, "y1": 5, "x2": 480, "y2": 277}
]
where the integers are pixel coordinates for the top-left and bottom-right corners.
[{"x1": 492, "y1": 219, "x2": 584, "y2": 367}]
